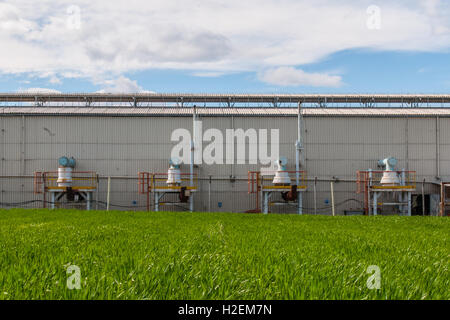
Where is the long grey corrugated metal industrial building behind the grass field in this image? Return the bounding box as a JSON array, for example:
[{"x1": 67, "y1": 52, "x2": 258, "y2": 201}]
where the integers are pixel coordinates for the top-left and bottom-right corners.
[{"x1": 0, "y1": 94, "x2": 450, "y2": 215}]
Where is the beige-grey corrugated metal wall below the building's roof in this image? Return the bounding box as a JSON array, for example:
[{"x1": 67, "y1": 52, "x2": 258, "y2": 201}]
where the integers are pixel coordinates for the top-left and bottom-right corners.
[{"x1": 0, "y1": 116, "x2": 444, "y2": 214}]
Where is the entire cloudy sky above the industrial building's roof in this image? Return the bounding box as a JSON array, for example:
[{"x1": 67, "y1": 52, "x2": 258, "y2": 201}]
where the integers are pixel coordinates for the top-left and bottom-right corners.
[{"x1": 0, "y1": 0, "x2": 450, "y2": 93}]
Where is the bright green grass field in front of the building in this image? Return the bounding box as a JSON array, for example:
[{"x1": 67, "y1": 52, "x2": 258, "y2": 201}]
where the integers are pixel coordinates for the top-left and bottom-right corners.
[{"x1": 0, "y1": 209, "x2": 450, "y2": 299}]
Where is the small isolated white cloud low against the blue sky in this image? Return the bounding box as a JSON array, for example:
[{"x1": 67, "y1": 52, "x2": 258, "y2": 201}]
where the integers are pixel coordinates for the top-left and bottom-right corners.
[{"x1": 259, "y1": 67, "x2": 342, "y2": 87}]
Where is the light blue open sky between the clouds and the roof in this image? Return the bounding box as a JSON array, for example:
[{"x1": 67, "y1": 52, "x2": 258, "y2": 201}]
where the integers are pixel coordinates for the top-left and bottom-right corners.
[{"x1": 7, "y1": 50, "x2": 450, "y2": 93}]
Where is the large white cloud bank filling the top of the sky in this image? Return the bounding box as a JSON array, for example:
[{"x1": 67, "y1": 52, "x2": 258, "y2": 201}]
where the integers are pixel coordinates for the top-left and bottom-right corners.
[{"x1": 0, "y1": 0, "x2": 450, "y2": 90}]
